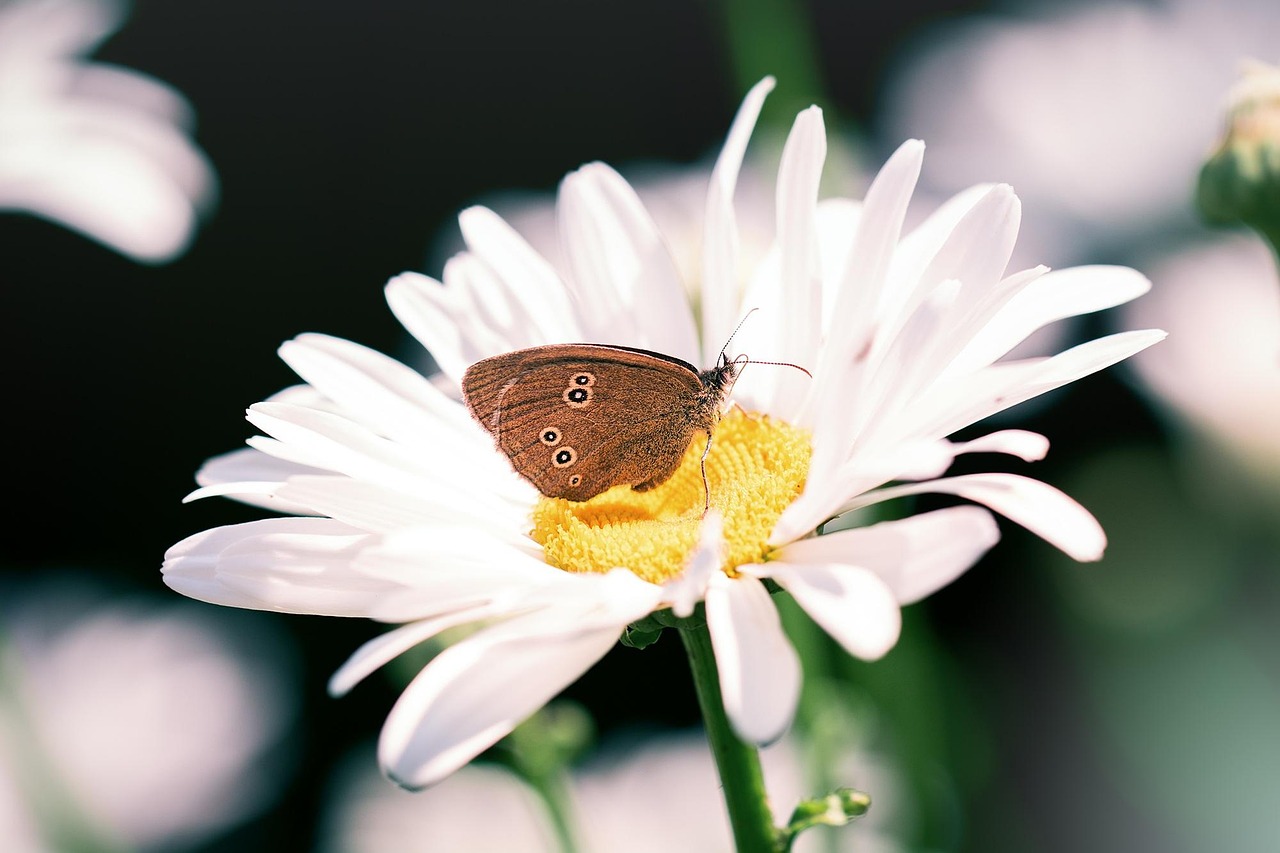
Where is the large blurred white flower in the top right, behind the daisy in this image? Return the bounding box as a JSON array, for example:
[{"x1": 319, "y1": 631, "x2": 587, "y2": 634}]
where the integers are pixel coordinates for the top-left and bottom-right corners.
[{"x1": 882, "y1": 0, "x2": 1280, "y2": 263}]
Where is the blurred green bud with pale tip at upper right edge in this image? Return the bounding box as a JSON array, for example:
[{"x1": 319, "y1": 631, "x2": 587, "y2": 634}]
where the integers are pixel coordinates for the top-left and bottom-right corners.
[{"x1": 1196, "y1": 61, "x2": 1280, "y2": 240}]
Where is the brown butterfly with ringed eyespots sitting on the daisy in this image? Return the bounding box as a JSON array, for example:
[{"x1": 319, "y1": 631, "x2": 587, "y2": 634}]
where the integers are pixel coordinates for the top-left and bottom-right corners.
[{"x1": 462, "y1": 343, "x2": 740, "y2": 501}]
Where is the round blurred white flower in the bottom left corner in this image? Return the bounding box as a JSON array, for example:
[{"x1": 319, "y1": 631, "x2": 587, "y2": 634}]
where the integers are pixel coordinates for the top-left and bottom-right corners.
[{"x1": 0, "y1": 584, "x2": 293, "y2": 850}]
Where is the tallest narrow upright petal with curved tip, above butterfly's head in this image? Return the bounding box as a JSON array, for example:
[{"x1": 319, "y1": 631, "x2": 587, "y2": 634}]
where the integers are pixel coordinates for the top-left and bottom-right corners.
[{"x1": 701, "y1": 77, "x2": 774, "y2": 366}]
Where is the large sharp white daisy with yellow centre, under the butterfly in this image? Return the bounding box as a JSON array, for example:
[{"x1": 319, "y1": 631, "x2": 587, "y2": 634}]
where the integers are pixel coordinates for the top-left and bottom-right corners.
[{"x1": 164, "y1": 79, "x2": 1164, "y2": 788}]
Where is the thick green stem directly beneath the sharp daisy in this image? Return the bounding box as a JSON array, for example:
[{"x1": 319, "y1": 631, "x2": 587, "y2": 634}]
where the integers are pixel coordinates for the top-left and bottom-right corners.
[{"x1": 680, "y1": 625, "x2": 780, "y2": 853}]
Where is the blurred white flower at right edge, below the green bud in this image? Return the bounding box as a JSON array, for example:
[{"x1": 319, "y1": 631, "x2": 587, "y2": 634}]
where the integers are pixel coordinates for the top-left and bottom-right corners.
[{"x1": 1125, "y1": 236, "x2": 1280, "y2": 482}]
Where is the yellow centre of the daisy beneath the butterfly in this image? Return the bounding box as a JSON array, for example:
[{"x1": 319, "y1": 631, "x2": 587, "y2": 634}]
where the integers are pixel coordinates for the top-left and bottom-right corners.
[{"x1": 531, "y1": 409, "x2": 812, "y2": 583}]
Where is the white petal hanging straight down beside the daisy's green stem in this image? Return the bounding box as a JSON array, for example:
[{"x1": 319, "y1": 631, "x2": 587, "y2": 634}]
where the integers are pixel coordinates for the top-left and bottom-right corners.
[{"x1": 707, "y1": 574, "x2": 800, "y2": 745}]
